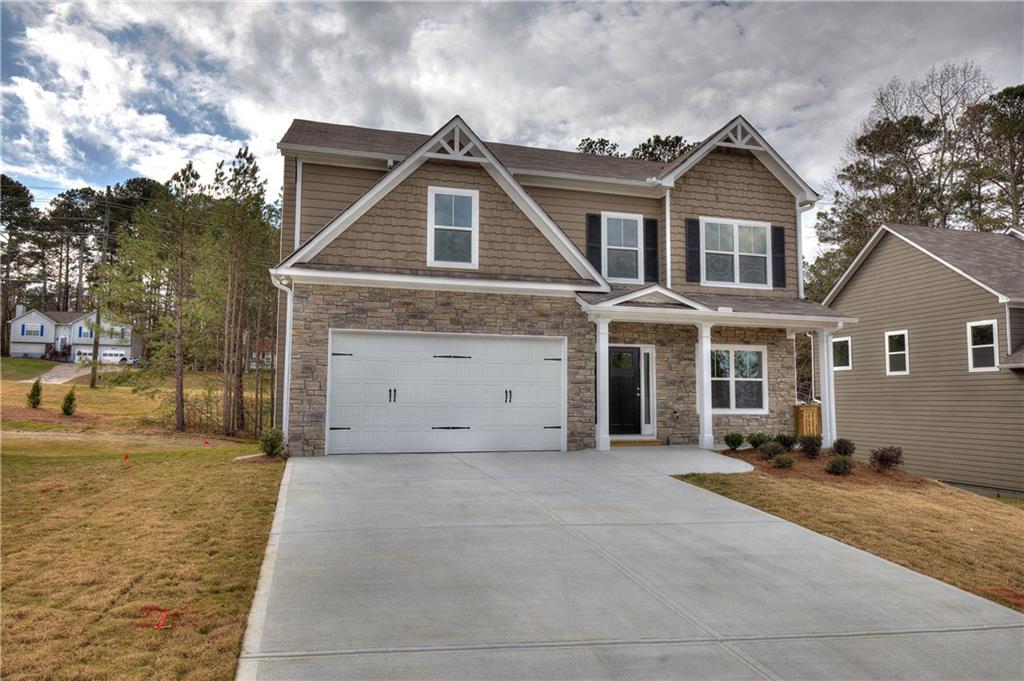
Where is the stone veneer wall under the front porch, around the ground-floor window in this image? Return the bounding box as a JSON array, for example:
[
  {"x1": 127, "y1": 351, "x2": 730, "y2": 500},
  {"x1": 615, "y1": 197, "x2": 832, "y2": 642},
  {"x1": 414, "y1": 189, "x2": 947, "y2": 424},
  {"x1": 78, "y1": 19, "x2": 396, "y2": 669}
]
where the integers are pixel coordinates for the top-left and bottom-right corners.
[{"x1": 608, "y1": 322, "x2": 797, "y2": 444}]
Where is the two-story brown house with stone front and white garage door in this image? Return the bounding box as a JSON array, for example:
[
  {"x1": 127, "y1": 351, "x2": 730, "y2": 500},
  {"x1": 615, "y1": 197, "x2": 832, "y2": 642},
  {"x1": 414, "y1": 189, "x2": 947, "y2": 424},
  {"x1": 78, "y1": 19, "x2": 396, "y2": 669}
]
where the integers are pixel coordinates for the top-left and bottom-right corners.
[{"x1": 271, "y1": 117, "x2": 849, "y2": 455}]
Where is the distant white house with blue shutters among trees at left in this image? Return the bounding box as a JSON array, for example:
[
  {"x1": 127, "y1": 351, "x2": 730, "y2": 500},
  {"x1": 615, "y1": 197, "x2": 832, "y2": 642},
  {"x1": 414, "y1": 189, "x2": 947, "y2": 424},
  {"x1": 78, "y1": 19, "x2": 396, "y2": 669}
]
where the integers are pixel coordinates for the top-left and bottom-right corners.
[{"x1": 9, "y1": 305, "x2": 135, "y2": 364}]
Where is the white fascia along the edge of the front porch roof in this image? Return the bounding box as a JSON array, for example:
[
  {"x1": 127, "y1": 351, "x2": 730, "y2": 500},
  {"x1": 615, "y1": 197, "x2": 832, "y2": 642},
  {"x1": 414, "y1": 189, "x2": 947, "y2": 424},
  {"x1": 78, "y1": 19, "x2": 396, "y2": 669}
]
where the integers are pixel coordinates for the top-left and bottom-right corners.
[{"x1": 577, "y1": 298, "x2": 857, "y2": 331}]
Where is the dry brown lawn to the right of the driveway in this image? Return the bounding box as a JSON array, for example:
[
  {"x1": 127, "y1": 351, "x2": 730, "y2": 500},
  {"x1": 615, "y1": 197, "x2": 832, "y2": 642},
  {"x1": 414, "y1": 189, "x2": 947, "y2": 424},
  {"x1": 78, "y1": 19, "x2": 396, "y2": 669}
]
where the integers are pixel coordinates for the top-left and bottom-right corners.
[{"x1": 679, "y1": 450, "x2": 1024, "y2": 610}]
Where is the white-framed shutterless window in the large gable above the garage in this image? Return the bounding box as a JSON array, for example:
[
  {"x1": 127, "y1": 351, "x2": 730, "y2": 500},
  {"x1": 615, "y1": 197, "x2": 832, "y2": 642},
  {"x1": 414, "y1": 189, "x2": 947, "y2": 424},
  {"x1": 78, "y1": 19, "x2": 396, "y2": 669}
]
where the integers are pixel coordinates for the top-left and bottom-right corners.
[{"x1": 427, "y1": 186, "x2": 480, "y2": 269}]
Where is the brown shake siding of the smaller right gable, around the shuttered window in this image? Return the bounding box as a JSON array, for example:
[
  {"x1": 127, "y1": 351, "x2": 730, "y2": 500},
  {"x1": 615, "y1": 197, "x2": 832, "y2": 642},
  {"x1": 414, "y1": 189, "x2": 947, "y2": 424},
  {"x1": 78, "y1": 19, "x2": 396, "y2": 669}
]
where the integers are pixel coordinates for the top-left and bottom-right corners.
[{"x1": 671, "y1": 148, "x2": 800, "y2": 298}]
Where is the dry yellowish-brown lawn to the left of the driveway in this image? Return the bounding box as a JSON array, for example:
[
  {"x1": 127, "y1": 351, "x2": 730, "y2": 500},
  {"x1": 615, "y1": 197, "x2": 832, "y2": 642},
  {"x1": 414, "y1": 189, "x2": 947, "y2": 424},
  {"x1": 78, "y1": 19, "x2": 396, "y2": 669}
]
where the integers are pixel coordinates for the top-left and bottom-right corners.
[{"x1": 0, "y1": 432, "x2": 283, "y2": 681}]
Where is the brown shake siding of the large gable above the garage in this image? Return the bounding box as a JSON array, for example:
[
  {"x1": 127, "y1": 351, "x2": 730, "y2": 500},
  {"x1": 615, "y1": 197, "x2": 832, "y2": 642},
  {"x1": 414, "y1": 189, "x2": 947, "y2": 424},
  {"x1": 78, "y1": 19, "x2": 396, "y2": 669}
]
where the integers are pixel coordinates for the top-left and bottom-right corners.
[{"x1": 306, "y1": 160, "x2": 581, "y2": 282}]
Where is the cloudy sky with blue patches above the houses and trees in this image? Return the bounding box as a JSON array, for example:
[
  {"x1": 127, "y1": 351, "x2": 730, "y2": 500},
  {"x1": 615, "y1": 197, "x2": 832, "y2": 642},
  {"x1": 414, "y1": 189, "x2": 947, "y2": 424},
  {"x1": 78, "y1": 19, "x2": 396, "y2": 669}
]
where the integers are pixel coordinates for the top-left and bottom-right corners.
[{"x1": 0, "y1": 1, "x2": 1024, "y2": 258}]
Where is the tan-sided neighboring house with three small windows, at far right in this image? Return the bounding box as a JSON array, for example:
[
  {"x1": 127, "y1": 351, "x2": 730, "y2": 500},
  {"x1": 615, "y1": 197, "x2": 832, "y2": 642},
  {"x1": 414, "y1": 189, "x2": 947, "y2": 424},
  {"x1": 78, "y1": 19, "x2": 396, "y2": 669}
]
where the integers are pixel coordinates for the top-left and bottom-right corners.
[{"x1": 824, "y1": 225, "x2": 1024, "y2": 493}]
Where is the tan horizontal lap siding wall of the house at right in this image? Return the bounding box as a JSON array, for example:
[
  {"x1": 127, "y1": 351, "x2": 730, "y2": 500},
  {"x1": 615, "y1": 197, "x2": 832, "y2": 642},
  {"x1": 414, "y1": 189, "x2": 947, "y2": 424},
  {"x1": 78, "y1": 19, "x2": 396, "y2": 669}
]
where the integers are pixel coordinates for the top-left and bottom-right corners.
[{"x1": 831, "y1": 235, "x2": 1024, "y2": 492}]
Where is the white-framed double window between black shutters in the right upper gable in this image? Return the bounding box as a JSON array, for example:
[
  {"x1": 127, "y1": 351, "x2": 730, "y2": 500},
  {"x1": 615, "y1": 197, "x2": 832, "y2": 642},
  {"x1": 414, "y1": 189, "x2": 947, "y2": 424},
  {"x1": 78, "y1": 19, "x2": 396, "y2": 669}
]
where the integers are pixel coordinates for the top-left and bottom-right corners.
[{"x1": 700, "y1": 217, "x2": 771, "y2": 289}]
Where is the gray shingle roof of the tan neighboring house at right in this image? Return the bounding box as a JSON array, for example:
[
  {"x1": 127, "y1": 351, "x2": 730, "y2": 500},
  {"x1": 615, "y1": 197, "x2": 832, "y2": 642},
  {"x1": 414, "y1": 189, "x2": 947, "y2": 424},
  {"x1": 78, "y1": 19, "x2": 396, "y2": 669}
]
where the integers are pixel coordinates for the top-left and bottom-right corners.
[{"x1": 886, "y1": 224, "x2": 1024, "y2": 298}]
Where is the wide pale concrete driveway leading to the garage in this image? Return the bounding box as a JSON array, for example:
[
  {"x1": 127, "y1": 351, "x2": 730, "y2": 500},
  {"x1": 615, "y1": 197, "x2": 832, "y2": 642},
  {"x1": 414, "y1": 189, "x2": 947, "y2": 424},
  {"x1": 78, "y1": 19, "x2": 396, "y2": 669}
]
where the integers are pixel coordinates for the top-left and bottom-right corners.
[{"x1": 239, "y1": 448, "x2": 1024, "y2": 681}]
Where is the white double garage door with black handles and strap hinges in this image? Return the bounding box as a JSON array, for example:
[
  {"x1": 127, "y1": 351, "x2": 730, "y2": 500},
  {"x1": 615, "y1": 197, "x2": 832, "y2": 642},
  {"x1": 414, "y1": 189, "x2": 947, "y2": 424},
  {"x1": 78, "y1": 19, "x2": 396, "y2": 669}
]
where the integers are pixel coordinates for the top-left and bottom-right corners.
[{"x1": 327, "y1": 331, "x2": 565, "y2": 454}]
